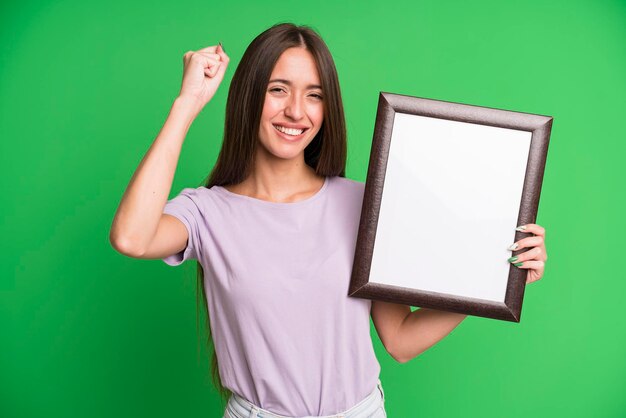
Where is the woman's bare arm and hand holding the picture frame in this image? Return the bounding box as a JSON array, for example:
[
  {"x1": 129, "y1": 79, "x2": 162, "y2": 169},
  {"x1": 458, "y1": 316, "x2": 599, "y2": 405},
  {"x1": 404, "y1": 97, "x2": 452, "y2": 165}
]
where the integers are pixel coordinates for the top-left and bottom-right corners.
[{"x1": 371, "y1": 224, "x2": 548, "y2": 363}]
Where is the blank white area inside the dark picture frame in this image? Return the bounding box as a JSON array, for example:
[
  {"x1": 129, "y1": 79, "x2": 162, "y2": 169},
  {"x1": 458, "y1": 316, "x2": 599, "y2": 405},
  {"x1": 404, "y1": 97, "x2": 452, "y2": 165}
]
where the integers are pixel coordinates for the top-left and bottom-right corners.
[{"x1": 369, "y1": 112, "x2": 531, "y2": 302}]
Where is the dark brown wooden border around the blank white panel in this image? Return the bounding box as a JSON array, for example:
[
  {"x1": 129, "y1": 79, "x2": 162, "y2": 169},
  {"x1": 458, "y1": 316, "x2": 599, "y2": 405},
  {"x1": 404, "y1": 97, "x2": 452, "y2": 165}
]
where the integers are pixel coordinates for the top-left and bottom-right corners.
[{"x1": 348, "y1": 92, "x2": 553, "y2": 322}]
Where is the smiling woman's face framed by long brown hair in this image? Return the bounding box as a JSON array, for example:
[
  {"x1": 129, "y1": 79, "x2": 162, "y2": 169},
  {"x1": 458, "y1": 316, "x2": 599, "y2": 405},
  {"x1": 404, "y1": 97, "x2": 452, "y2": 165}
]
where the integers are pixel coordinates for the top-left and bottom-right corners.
[{"x1": 259, "y1": 48, "x2": 324, "y2": 159}]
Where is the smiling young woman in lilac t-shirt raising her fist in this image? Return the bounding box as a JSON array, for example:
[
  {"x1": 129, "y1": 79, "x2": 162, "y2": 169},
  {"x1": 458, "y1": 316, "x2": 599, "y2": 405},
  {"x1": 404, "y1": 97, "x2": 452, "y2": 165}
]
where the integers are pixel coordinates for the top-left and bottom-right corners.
[{"x1": 111, "y1": 24, "x2": 547, "y2": 418}]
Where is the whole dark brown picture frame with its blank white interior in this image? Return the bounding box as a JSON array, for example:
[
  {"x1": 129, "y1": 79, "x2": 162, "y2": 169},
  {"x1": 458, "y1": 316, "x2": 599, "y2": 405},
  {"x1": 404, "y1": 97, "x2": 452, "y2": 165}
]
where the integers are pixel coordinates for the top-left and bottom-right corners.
[{"x1": 348, "y1": 92, "x2": 553, "y2": 322}]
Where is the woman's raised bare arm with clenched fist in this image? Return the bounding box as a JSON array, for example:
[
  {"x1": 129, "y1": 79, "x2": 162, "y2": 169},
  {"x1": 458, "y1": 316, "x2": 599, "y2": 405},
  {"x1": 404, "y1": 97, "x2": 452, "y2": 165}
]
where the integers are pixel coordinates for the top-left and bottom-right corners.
[{"x1": 109, "y1": 45, "x2": 229, "y2": 258}]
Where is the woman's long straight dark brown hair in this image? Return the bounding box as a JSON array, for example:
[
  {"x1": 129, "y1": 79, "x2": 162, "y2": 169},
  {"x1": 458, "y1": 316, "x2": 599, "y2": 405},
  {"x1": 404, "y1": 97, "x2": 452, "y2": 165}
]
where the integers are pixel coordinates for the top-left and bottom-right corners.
[{"x1": 196, "y1": 23, "x2": 347, "y2": 401}]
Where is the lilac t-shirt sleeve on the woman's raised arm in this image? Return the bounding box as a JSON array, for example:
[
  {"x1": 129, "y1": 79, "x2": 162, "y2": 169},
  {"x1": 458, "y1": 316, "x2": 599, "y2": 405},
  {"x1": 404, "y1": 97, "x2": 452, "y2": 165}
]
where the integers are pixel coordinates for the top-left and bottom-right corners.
[{"x1": 163, "y1": 188, "x2": 202, "y2": 266}]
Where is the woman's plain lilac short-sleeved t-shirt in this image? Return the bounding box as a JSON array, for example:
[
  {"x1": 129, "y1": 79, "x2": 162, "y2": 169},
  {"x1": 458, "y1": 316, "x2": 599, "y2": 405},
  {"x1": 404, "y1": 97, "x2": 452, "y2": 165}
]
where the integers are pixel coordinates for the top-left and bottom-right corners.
[{"x1": 163, "y1": 176, "x2": 380, "y2": 416}]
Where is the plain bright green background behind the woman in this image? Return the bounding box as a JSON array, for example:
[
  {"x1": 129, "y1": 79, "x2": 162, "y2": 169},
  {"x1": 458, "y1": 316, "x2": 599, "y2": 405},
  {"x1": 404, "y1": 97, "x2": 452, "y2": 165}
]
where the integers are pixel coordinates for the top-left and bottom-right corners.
[{"x1": 0, "y1": 0, "x2": 626, "y2": 418}]
